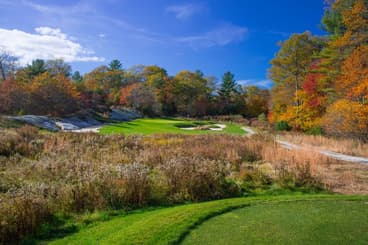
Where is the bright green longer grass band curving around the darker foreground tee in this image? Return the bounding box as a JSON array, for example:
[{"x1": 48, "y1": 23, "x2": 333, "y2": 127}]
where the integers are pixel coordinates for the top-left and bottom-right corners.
[{"x1": 51, "y1": 195, "x2": 368, "y2": 244}]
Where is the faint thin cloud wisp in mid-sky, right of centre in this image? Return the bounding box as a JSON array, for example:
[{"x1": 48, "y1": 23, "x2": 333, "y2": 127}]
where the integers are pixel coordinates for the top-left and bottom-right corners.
[{"x1": 175, "y1": 24, "x2": 248, "y2": 48}]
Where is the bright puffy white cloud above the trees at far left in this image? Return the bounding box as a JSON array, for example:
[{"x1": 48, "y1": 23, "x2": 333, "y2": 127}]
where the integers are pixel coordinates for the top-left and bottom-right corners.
[{"x1": 0, "y1": 27, "x2": 104, "y2": 65}]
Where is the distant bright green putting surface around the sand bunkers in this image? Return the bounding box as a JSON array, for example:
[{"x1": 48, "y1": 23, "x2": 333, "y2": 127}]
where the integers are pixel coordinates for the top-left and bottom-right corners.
[{"x1": 100, "y1": 118, "x2": 245, "y2": 135}]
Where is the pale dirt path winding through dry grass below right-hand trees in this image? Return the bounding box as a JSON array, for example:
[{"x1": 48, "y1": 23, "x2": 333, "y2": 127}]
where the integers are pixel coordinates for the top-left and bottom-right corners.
[{"x1": 242, "y1": 127, "x2": 368, "y2": 165}]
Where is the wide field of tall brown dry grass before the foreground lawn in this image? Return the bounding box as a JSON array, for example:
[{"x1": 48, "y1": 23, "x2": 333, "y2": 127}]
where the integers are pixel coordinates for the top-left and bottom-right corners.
[{"x1": 0, "y1": 128, "x2": 368, "y2": 243}]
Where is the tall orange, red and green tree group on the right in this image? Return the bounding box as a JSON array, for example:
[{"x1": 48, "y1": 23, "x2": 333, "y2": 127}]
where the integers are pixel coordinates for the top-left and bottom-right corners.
[{"x1": 269, "y1": 0, "x2": 368, "y2": 140}]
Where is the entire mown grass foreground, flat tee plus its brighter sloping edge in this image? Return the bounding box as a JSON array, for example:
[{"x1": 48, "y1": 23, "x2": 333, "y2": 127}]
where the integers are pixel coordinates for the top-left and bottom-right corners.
[{"x1": 47, "y1": 195, "x2": 368, "y2": 244}]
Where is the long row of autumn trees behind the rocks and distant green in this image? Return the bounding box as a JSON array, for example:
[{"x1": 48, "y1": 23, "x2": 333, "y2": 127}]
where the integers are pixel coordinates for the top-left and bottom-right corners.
[{"x1": 0, "y1": 52, "x2": 269, "y2": 117}]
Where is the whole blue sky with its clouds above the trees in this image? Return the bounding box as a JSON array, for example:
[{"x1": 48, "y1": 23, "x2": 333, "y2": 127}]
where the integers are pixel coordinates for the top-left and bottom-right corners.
[{"x1": 0, "y1": 0, "x2": 324, "y2": 86}]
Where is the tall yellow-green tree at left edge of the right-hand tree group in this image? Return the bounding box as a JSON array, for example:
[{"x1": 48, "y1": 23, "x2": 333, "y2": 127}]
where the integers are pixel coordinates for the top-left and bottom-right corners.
[{"x1": 269, "y1": 32, "x2": 323, "y2": 122}]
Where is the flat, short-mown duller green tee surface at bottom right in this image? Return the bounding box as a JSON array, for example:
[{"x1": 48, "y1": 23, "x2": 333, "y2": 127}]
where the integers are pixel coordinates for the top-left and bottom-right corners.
[{"x1": 183, "y1": 200, "x2": 368, "y2": 244}]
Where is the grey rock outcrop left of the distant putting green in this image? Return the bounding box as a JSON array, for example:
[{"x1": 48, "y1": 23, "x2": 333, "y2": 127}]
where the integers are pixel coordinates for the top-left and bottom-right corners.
[{"x1": 10, "y1": 109, "x2": 141, "y2": 131}]
